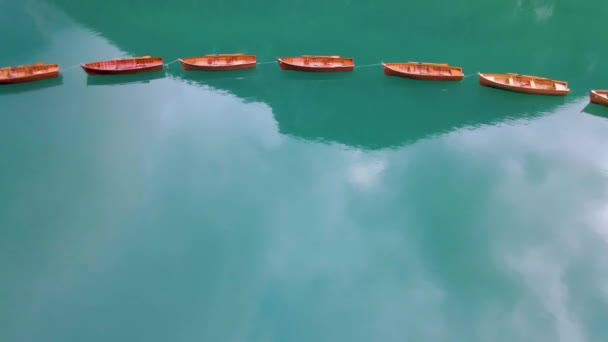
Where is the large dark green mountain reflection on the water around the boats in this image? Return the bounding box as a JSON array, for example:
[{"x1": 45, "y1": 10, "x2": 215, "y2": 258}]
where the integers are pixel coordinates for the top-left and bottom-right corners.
[{"x1": 47, "y1": 0, "x2": 608, "y2": 149}]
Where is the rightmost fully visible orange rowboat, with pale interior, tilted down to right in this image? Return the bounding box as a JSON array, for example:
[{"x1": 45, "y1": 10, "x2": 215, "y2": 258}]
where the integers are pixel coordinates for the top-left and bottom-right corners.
[{"x1": 478, "y1": 73, "x2": 570, "y2": 96}]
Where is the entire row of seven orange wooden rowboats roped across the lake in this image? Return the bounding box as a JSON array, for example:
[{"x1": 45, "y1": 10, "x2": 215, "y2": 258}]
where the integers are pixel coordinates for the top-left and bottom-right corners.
[{"x1": 0, "y1": 53, "x2": 608, "y2": 106}]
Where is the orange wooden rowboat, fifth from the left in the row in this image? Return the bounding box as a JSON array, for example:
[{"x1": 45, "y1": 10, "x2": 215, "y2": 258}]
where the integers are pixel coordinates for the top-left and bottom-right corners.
[{"x1": 382, "y1": 62, "x2": 464, "y2": 81}]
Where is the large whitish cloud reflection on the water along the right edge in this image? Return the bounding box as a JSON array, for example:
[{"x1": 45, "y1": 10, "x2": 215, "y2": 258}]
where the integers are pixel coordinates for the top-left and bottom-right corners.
[{"x1": 446, "y1": 98, "x2": 608, "y2": 341}]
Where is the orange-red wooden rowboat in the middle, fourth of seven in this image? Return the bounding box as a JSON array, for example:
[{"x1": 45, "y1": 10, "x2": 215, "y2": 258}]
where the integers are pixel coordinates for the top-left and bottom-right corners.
[{"x1": 277, "y1": 55, "x2": 355, "y2": 72}]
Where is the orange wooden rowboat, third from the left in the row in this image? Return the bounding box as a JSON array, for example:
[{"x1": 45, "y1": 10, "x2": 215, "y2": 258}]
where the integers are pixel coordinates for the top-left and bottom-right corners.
[{"x1": 178, "y1": 53, "x2": 256, "y2": 71}]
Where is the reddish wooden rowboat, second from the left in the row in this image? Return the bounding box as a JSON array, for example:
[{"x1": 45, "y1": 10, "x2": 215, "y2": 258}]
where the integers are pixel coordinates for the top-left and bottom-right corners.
[{"x1": 80, "y1": 56, "x2": 163, "y2": 75}]
